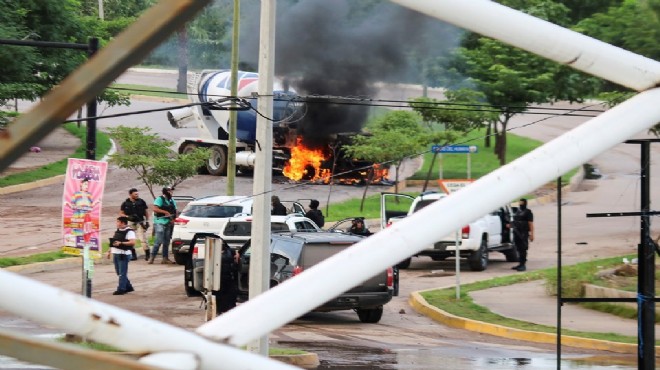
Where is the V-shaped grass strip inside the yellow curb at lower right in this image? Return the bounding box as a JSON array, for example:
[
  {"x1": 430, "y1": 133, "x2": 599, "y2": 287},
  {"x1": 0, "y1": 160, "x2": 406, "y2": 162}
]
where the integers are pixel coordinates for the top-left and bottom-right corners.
[{"x1": 422, "y1": 256, "x2": 660, "y2": 345}]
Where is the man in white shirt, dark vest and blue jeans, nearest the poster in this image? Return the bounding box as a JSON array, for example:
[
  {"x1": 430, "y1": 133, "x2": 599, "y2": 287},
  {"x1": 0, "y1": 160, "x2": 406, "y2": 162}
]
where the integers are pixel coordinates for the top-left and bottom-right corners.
[{"x1": 108, "y1": 216, "x2": 135, "y2": 295}]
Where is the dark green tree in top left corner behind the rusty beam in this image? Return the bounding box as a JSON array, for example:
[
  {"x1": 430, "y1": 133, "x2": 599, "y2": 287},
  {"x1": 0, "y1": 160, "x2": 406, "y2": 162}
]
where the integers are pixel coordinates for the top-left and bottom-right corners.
[{"x1": 0, "y1": 0, "x2": 130, "y2": 116}]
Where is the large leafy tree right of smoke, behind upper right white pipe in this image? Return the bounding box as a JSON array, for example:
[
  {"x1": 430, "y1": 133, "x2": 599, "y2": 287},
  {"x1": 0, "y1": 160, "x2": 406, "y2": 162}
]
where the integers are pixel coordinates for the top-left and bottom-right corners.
[{"x1": 440, "y1": 0, "x2": 600, "y2": 165}]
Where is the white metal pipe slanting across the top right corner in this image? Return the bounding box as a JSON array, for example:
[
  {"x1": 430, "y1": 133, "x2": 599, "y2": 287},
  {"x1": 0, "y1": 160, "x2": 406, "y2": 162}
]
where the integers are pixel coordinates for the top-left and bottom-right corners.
[{"x1": 391, "y1": 0, "x2": 660, "y2": 91}]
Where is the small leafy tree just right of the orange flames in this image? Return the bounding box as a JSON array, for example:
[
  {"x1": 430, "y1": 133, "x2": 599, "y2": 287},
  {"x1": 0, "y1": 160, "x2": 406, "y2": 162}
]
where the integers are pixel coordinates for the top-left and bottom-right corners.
[{"x1": 343, "y1": 111, "x2": 453, "y2": 192}]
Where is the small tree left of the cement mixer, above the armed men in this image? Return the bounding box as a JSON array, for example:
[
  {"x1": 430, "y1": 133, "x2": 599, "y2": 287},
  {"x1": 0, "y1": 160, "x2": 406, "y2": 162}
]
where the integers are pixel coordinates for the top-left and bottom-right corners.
[{"x1": 110, "y1": 126, "x2": 209, "y2": 199}]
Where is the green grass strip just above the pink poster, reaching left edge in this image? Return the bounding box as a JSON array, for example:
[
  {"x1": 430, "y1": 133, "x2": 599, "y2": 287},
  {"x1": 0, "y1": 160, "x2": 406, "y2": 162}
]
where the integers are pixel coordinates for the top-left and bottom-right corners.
[{"x1": 0, "y1": 123, "x2": 112, "y2": 188}]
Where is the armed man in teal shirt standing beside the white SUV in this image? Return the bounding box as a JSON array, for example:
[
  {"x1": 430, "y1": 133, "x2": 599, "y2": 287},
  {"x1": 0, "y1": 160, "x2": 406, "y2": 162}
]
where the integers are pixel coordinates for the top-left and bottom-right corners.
[{"x1": 149, "y1": 186, "x2": 176, "y2": 265}]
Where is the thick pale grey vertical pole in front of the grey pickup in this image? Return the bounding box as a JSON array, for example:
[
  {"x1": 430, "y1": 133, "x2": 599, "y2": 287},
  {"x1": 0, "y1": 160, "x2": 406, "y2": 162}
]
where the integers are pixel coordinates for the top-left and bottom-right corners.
[{"x1": 249, "y1": 0, "x2": 276, "y2": 356}]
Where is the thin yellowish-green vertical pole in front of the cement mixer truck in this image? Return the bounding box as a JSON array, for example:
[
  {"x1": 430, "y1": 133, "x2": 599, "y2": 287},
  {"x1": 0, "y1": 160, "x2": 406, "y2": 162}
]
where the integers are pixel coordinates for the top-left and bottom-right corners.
[{"x1": 227, "y1": 0, "x2": 241, "y2": 195}]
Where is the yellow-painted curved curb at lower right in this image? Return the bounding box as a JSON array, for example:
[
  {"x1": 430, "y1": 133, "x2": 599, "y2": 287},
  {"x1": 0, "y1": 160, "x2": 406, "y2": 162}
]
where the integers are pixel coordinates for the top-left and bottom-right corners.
[{"x1": 408, "y1": 289, "x2": 660, "y2": 357}]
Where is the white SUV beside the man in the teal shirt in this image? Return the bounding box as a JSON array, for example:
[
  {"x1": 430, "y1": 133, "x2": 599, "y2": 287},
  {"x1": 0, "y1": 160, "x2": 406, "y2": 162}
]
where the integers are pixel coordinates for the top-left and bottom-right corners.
[{"x1": 171, "y1": 195, "x2": 253, "y2": 265}]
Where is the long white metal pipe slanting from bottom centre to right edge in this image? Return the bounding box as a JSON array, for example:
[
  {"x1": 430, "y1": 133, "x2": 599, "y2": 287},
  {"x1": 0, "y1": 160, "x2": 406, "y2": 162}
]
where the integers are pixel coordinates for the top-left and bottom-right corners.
[{"x1": 198, "y1": 88, "x2": 660, "y2": 345}]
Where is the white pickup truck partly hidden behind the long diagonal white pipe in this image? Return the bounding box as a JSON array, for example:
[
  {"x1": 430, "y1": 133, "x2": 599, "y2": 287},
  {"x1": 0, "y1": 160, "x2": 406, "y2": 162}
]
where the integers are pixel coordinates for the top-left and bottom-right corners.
[{"x1": 380, "y1": 192, "x2": 518, "y2": 271}]
